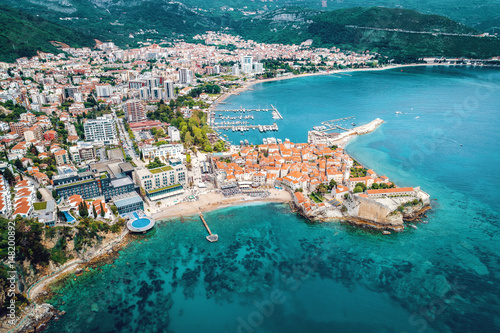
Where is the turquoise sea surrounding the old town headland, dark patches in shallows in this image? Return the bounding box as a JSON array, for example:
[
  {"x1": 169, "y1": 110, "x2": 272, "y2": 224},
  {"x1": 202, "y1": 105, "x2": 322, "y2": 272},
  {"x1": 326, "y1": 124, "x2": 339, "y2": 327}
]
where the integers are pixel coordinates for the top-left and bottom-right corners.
[{"x1": 47, "y1": 66, "x2": 500, "y2": 333}]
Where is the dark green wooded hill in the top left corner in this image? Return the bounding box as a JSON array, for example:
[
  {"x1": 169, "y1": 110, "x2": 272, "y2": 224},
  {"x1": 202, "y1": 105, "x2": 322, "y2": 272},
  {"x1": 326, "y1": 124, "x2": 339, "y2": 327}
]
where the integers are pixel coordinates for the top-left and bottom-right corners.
[{"x1": 0, "y1": 5, "x2": 95, "y2": 62}]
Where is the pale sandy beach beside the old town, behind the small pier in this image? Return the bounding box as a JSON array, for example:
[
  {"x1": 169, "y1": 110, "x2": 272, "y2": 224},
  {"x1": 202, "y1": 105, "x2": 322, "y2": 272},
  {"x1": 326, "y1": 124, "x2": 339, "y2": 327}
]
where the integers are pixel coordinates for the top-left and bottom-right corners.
[{"x1": 152, "y1": 189, "x2": 292, "y2": 220}]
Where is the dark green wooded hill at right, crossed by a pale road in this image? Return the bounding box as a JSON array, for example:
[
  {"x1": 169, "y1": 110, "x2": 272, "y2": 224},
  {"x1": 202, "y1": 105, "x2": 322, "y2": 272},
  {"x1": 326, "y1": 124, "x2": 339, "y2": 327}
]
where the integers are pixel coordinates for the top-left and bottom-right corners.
[{"x1": 308, "y1": 7, "x2": 500, "y2": 58}]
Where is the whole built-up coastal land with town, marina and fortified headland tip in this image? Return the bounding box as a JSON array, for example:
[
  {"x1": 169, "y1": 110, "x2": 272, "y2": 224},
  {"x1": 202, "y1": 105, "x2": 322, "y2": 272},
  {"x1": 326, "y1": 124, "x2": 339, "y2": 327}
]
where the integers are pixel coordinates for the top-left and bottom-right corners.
[{"x1": 0, "y1": 28, "x2": 438, "y2": 330}]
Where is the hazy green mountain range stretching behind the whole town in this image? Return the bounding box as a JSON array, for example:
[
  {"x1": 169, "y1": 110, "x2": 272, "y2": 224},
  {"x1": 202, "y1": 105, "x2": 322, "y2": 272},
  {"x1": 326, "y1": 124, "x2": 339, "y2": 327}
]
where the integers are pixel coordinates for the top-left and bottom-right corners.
[{"x1": 0, "y1": 0, "x2": 500, "y2": 61}]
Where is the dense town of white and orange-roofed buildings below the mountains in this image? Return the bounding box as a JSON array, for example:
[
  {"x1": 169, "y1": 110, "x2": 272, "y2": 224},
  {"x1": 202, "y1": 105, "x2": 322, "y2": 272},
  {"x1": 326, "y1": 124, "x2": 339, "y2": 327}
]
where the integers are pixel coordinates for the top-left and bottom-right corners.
[{"x1": 0, "y1": 32, "x2": 406, "y2": 226}]
